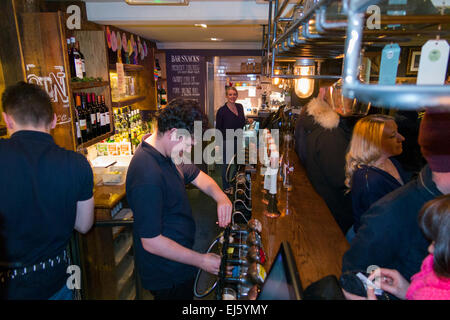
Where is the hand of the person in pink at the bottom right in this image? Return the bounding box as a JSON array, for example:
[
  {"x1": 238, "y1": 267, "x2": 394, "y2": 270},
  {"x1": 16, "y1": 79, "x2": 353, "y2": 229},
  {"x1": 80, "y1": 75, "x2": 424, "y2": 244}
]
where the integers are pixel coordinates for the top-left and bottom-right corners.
[{"x1": 369, "y1": 268, "x2": 409, "y2": 300}]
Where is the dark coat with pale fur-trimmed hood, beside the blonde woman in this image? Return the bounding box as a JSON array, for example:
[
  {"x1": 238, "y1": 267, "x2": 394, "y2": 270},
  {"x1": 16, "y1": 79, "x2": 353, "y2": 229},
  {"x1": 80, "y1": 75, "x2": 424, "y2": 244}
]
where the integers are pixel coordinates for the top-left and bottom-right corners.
[{"x1": 304, "y1": 99, "x2": 355, "y2": 234}]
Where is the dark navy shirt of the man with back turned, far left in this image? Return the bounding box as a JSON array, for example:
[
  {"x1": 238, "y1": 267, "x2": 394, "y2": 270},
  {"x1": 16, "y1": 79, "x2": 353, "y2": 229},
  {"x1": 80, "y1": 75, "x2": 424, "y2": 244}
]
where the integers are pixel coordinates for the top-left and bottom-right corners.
[{"x1": 0, "y1": 130, "x2": 94, "y2": 299}]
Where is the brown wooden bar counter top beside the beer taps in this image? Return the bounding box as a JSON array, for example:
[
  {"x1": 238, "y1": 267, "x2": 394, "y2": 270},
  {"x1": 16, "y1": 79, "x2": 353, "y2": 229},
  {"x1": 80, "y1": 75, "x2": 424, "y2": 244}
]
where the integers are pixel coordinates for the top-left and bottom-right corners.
[{"x1": 252, "y1": 151, "x2": 349, "y2": 288}]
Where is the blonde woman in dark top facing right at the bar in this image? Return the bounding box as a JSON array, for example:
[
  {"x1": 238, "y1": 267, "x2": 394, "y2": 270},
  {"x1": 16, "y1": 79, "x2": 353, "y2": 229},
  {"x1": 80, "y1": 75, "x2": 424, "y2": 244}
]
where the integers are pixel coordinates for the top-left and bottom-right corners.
[{"x1": 345, "y1": 114, "x2": 409, "y2": 240}]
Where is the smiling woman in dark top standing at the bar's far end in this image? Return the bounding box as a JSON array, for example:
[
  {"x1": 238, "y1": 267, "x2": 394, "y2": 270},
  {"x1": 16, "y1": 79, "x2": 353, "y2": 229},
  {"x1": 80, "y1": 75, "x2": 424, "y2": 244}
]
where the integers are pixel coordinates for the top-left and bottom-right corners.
[{"x1": 216, "y1": 87, "x2": 246, "y2": 194}]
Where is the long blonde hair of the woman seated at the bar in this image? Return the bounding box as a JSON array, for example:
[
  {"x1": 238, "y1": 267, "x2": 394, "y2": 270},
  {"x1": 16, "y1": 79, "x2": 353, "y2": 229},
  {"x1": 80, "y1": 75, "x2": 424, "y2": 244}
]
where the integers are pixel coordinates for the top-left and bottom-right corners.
[{"x1": 345, "y1": 114, "x2": 394, "y2": 189}]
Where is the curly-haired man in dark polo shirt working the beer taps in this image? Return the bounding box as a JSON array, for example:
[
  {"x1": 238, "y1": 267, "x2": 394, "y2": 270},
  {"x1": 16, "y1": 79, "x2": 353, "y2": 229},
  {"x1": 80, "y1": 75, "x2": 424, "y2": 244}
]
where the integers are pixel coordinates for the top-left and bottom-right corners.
[{"x1": 126, "y1": 99, "x2": 232, "y2": 300}]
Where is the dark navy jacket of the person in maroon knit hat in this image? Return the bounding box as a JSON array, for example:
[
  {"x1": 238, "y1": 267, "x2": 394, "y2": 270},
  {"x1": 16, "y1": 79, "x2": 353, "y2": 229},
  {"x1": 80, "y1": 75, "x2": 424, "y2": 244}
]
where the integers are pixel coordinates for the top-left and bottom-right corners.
[{"x1": 342, "y1": 165, "x2": 442, "y2": 279}]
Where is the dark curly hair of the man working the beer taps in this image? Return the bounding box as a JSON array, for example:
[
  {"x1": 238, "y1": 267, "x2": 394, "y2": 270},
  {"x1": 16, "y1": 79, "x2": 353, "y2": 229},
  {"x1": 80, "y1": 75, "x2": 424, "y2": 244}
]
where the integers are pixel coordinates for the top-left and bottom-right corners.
[{"x1": 157, "y1": 98, "x2": 207, "y2": 134}]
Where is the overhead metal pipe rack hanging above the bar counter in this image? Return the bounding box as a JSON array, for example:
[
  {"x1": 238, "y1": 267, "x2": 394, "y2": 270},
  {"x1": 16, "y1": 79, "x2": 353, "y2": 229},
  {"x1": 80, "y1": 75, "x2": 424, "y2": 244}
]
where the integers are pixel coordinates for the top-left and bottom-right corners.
[{"x1": 267, "y1": 0, "x2": 450, "y2": 110}]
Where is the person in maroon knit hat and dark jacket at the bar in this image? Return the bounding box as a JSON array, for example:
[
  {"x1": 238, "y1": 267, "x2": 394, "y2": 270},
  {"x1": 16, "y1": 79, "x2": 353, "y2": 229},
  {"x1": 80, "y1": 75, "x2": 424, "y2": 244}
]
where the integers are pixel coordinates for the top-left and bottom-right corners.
[{"x1": 342, "y1": 109, "x2": 450, "y2": 289}]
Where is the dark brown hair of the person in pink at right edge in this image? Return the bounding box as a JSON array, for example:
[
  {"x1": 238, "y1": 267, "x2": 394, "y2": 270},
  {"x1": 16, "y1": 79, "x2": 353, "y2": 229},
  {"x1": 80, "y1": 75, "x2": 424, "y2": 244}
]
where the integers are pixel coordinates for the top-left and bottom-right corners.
[{"x1": 419, "y1": 194, "x2": 450, "y2": 278}]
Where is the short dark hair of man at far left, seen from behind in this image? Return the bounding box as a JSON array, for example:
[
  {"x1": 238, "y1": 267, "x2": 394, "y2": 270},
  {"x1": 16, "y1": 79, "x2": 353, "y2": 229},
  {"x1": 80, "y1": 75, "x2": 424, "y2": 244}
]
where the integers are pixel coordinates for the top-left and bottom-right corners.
[{"x1": 2, "y1": 81, "x2": 53, "y2": 127}]
